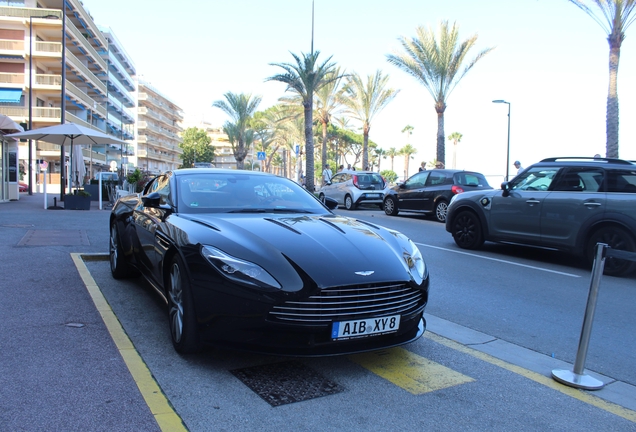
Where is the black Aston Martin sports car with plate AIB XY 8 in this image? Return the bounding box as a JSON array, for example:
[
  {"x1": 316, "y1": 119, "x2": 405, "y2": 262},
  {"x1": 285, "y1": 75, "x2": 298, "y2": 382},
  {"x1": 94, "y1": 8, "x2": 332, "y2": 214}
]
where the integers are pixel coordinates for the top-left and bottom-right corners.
[{"x1": 110, "y1": 168, "x2": 429, "y2": 356}]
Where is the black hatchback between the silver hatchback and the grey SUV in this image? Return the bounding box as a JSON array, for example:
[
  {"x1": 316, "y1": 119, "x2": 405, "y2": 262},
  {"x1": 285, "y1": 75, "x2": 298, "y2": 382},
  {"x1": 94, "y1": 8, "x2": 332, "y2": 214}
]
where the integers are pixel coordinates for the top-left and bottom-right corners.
[{"x1": 384, "y1": 169, "x2": 492, "y2": 222}]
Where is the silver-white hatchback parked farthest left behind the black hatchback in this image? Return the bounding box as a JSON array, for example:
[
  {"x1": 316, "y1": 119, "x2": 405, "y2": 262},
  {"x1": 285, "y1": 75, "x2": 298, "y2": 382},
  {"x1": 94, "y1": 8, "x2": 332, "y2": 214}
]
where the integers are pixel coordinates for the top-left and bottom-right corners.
[{"x1": 318, "y1": 171, "x2": 387, "y2": 210}]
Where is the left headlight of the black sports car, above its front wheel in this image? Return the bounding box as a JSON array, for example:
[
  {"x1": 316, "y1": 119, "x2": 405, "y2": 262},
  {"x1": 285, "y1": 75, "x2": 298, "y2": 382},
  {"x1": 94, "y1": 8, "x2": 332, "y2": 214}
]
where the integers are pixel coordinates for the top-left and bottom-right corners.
[{"x1": 201, "y1": 246, "x2": 282, "y2": 289}]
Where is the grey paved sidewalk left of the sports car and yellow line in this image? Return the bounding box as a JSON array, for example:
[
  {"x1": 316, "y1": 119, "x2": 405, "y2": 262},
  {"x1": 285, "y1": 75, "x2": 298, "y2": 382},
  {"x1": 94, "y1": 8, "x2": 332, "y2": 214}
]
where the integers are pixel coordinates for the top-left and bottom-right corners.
[{"x1": 0, "y1": 193, "x2": 158, "y2": 431}]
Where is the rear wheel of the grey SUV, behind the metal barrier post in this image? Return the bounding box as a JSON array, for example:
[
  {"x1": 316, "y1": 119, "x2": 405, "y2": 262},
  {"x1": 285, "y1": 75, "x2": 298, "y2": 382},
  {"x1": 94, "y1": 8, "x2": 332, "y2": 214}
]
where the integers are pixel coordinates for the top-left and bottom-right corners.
[{"x1": 585, "y1": 226, "x2": 636, "y2": 276}]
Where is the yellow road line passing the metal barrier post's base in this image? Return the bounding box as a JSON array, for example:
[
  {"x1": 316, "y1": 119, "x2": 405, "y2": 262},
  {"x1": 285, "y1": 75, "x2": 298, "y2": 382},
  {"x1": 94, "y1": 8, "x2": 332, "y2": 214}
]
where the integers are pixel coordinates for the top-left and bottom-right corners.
[{"x1": 424, "y1": 331, "x2": 636, "y2": 423}]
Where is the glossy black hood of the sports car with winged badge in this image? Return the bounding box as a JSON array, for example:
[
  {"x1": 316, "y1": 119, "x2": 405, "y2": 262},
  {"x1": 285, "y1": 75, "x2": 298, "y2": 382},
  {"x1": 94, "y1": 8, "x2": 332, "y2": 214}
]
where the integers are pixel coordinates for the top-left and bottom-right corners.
[{"x1": 182, "y1": 214, "x2": 422, "y2": 291}]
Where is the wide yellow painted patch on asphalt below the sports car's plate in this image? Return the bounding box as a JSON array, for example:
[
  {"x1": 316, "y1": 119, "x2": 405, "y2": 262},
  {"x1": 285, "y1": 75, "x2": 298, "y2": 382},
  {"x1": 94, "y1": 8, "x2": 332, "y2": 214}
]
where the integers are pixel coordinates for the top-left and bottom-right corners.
[{"x1": 349, "y1": 348, "x2": 474, "y2": 395}]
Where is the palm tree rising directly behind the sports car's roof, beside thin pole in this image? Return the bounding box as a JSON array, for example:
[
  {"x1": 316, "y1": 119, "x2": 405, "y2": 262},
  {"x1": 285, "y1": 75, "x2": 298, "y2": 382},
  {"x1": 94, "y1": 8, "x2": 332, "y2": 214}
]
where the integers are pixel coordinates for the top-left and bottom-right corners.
[{"x1": 265, "y1": 51, "x2": 338, "y2": 192}]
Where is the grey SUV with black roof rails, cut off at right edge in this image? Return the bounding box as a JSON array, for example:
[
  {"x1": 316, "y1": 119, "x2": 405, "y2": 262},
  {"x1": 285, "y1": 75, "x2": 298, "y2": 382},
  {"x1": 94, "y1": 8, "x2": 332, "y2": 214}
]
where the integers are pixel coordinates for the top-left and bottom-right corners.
[{"x1": 446, "y1": 157, "x2": 636, "y2": 276}]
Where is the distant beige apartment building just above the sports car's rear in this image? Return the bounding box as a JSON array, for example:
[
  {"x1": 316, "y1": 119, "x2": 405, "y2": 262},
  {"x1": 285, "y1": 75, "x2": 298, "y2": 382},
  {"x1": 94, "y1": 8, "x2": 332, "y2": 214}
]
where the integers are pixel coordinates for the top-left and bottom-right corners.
[{"x1": 137, "y1": 79, "x2": 183, "y2": 174}]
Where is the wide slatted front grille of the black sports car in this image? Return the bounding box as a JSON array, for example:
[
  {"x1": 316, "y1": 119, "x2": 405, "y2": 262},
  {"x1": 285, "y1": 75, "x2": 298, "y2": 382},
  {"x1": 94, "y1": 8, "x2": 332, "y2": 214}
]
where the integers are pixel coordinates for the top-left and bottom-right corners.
[{"x1": 269, "y1": 283, "x2": 425, "y2": 325}]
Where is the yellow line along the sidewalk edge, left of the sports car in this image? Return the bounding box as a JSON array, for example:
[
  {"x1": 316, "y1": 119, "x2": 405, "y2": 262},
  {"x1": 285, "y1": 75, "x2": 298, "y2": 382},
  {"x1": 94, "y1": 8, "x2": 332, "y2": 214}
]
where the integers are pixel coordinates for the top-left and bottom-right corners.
[{"x1": 71, "y1": 253, "x2": 187, "y2": 432}]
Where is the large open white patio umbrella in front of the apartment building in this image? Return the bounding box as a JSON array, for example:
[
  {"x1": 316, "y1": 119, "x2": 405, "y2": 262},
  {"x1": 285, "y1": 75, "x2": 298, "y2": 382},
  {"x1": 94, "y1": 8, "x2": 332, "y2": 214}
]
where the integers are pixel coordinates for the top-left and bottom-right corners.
[{"x1": 7, "y1": 123, "x2": 126, "y2": 194}]
